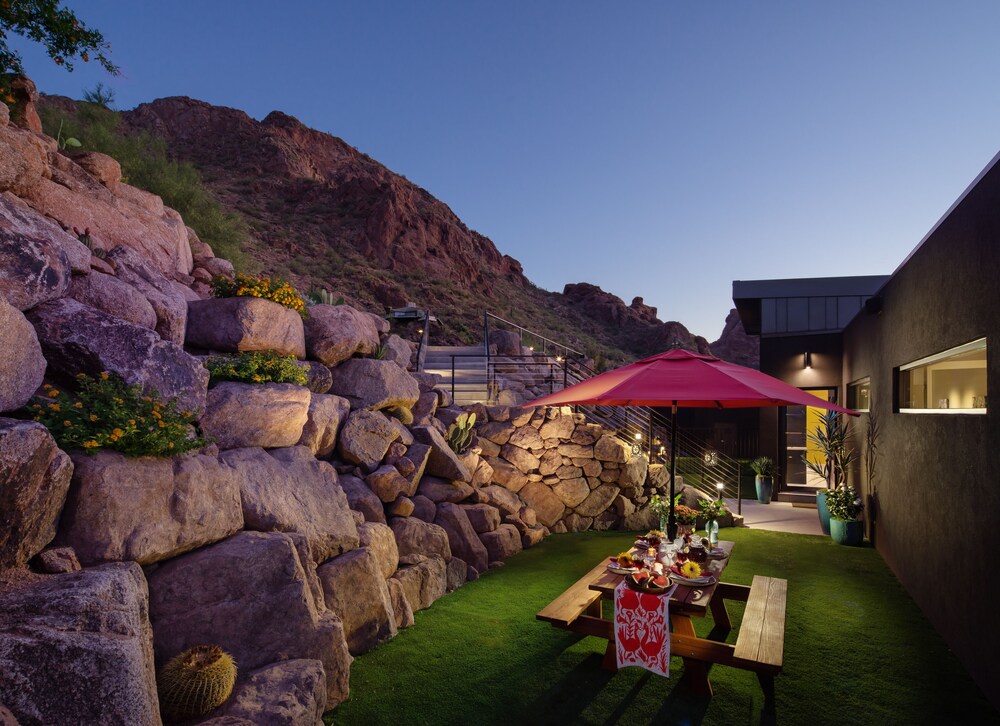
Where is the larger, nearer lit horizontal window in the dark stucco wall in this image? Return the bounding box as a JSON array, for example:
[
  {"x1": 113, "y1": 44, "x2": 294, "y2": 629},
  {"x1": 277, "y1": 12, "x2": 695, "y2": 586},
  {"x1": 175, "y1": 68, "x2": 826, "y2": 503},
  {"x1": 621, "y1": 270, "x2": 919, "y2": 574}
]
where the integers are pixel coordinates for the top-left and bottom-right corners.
[{"x1": 896, "y1": 338, "x2": 986, "y2": 413}]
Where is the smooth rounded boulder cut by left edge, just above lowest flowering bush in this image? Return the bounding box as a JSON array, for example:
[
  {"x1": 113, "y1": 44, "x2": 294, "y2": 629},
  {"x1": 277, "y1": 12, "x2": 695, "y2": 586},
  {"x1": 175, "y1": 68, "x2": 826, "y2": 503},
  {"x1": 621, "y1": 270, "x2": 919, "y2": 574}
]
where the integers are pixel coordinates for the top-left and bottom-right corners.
[{"x1": 0, "y1": 297, "x2": 46, "y2": 412}]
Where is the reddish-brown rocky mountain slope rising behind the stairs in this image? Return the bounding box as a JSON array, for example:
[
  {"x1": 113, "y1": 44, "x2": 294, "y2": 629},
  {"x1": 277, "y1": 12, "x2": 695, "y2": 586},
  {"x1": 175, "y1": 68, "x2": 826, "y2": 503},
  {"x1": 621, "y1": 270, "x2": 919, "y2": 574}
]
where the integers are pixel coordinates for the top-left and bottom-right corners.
[{"x1": 46, "y1": 98, "x2": 756, "y2": 364}]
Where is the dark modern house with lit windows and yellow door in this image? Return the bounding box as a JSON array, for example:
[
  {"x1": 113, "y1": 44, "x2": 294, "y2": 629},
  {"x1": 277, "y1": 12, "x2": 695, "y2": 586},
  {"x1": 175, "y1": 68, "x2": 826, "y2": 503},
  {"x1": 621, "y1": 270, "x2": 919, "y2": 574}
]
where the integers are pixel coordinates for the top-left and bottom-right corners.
[{"x1": 733, "y1": 155, "x2": 1000, "y2": 706}]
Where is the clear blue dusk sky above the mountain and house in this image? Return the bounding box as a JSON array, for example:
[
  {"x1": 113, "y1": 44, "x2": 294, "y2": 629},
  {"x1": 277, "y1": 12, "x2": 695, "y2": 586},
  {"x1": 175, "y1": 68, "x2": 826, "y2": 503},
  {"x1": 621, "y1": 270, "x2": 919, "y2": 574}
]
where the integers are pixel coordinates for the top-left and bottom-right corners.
[{"x1": 17, "y1": 0, "x2": 1000, "y2": 340}]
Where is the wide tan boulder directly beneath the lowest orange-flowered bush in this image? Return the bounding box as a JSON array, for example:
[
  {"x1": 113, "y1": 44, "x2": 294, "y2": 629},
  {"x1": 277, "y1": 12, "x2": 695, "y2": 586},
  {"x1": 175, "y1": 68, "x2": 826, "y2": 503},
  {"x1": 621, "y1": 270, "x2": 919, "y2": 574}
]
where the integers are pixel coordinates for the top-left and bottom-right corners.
[{"x1": 58, "y1": 451, "x2": 243, "y2": 565}]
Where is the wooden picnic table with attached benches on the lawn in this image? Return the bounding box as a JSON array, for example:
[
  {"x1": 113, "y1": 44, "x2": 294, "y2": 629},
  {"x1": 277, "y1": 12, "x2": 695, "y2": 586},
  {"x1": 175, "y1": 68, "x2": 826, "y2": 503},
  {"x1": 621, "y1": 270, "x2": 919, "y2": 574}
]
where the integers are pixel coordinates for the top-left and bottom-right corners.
[{"x1": 535, "y1": 541, "x2": 788, "y2": 707}]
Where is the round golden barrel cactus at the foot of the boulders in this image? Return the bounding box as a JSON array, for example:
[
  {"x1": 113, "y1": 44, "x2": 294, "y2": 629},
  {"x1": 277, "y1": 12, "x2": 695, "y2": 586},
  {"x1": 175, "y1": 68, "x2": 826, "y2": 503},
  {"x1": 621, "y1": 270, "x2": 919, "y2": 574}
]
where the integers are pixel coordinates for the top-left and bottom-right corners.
[{"x1": 156, "y1": 645, "x2": 236, "y2": 720}]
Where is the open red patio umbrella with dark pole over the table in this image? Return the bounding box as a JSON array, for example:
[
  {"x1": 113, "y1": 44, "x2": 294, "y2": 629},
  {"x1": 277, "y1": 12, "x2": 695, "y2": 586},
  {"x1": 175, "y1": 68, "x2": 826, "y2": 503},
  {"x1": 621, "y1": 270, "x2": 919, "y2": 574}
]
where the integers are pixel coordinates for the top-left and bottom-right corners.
[{"x1": 526, "y1": 349, "x2": 859, "y2": 539}]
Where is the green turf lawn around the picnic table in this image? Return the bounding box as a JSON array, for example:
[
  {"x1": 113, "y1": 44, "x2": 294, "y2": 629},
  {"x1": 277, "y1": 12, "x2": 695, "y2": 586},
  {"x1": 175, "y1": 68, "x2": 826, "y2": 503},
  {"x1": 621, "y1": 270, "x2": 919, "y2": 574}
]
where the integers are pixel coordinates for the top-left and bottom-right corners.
[{"x1": 328, "y1": 529, "x2": 1000, "y2": 726}]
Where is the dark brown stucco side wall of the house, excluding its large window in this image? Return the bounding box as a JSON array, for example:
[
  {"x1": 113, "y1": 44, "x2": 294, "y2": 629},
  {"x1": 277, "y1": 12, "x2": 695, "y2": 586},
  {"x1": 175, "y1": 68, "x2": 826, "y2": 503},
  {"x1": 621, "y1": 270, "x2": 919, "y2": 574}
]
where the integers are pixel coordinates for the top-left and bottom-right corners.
[{"x1": 843, "y1": 152, "x2": 1000, "y2": 707}]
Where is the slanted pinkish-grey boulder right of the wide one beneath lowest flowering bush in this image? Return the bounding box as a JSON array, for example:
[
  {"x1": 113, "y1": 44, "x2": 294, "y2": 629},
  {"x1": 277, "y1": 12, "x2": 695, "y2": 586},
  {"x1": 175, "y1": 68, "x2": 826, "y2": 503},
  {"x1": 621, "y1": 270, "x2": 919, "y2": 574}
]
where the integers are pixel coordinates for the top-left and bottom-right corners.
[{"x1": 222, "y1": 446, "x2": 358, "y2": 562}]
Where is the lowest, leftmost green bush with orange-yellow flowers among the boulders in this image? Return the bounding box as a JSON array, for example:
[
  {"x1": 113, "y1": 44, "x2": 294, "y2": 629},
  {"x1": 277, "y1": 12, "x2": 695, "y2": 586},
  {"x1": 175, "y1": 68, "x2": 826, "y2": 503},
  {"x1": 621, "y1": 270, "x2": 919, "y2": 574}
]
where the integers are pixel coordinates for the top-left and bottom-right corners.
[{"x1": 28, "y1": 372, "x2": 205, "y2": 456}]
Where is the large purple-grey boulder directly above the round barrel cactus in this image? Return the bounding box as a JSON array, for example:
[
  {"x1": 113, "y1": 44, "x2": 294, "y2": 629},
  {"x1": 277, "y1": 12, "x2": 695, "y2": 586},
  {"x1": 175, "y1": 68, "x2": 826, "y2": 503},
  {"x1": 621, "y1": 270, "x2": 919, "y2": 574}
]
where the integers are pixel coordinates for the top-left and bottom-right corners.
[{"x1": 149, "y1": 532, "x2": 354, "y2": 707}]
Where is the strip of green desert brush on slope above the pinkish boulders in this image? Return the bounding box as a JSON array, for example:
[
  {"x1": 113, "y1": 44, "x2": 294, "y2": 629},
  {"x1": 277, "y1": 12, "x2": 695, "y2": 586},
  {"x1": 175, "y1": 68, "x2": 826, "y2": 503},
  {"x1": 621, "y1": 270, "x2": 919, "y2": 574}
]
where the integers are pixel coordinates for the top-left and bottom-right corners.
[{"x1": 39, "y1": 103, "x2": 253, "y2": 270}]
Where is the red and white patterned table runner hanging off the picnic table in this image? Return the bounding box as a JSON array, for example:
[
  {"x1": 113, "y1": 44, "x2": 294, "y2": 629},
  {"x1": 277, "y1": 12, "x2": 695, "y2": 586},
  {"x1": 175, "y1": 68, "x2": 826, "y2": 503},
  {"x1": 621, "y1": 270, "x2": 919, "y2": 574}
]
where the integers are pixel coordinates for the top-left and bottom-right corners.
[{"x1": 615, "y1": 580, "x2": 670, "y2": 676}]
